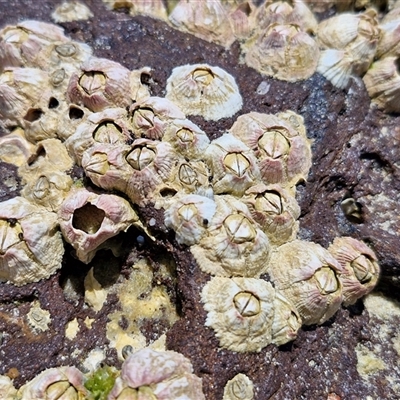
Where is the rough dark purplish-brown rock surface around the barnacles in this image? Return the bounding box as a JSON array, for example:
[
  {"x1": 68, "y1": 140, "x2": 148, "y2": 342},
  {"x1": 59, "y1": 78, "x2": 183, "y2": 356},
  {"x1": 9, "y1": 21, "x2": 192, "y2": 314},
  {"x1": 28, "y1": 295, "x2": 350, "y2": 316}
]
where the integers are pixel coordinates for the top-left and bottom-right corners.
[{"x1": 0, "y1": 0, "x2": 400, "y2": 400}]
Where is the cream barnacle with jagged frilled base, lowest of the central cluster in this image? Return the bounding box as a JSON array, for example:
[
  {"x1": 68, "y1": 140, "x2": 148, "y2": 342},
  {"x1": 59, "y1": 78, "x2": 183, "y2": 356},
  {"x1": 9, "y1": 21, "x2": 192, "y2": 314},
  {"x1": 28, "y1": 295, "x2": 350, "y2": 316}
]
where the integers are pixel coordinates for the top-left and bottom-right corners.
[{"x1": 201, "y1": 277, "x2": 275, "y2": 352}]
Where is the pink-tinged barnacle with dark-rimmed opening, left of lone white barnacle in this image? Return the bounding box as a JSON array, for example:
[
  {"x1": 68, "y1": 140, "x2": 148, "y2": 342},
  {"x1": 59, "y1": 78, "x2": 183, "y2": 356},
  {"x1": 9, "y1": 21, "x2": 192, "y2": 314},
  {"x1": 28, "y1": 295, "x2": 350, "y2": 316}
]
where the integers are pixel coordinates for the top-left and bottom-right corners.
[{"x1": 67, "y1": 57, "x2": 132, "y2": 112}]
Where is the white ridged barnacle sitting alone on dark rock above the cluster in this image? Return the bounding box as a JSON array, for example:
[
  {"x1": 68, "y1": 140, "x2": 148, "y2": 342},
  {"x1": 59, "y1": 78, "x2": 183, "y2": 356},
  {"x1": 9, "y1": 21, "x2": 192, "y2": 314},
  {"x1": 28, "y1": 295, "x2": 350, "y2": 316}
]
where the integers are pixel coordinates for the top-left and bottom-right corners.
[{"x1": 165, "y1": 63, "x2": 243, "y2": 121}]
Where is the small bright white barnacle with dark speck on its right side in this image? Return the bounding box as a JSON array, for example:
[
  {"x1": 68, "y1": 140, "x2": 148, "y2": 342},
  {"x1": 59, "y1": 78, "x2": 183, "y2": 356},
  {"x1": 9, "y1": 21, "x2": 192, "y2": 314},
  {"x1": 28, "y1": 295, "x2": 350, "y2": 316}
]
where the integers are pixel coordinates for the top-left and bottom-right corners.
[{"x1": 164, "y1": 194, "x2": 216, "y2": 246}]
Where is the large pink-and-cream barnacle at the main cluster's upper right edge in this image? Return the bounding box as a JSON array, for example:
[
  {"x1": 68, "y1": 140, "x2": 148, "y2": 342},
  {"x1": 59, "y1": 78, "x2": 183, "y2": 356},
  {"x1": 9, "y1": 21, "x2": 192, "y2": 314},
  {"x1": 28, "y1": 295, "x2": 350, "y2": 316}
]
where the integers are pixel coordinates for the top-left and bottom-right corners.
[{"x1": 230, "y1": 112, "x2": 311, "y2": 187}]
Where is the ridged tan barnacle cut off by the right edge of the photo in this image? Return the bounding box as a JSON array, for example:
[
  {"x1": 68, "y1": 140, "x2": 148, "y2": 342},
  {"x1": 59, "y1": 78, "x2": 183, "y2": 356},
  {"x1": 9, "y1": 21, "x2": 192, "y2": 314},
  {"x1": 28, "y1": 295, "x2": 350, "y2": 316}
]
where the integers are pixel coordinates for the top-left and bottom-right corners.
[{"x1": 363, "y1": 57, "x2": 400, "y2": 113}]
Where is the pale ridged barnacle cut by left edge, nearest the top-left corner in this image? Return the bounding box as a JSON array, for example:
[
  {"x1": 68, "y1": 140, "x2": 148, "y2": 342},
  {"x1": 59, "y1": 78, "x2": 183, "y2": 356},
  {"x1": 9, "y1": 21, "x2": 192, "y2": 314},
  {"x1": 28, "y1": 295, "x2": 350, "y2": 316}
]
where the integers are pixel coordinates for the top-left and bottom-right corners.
[{"x1": 0, "y1": 20, "x2": 69, "y2": 72}]
